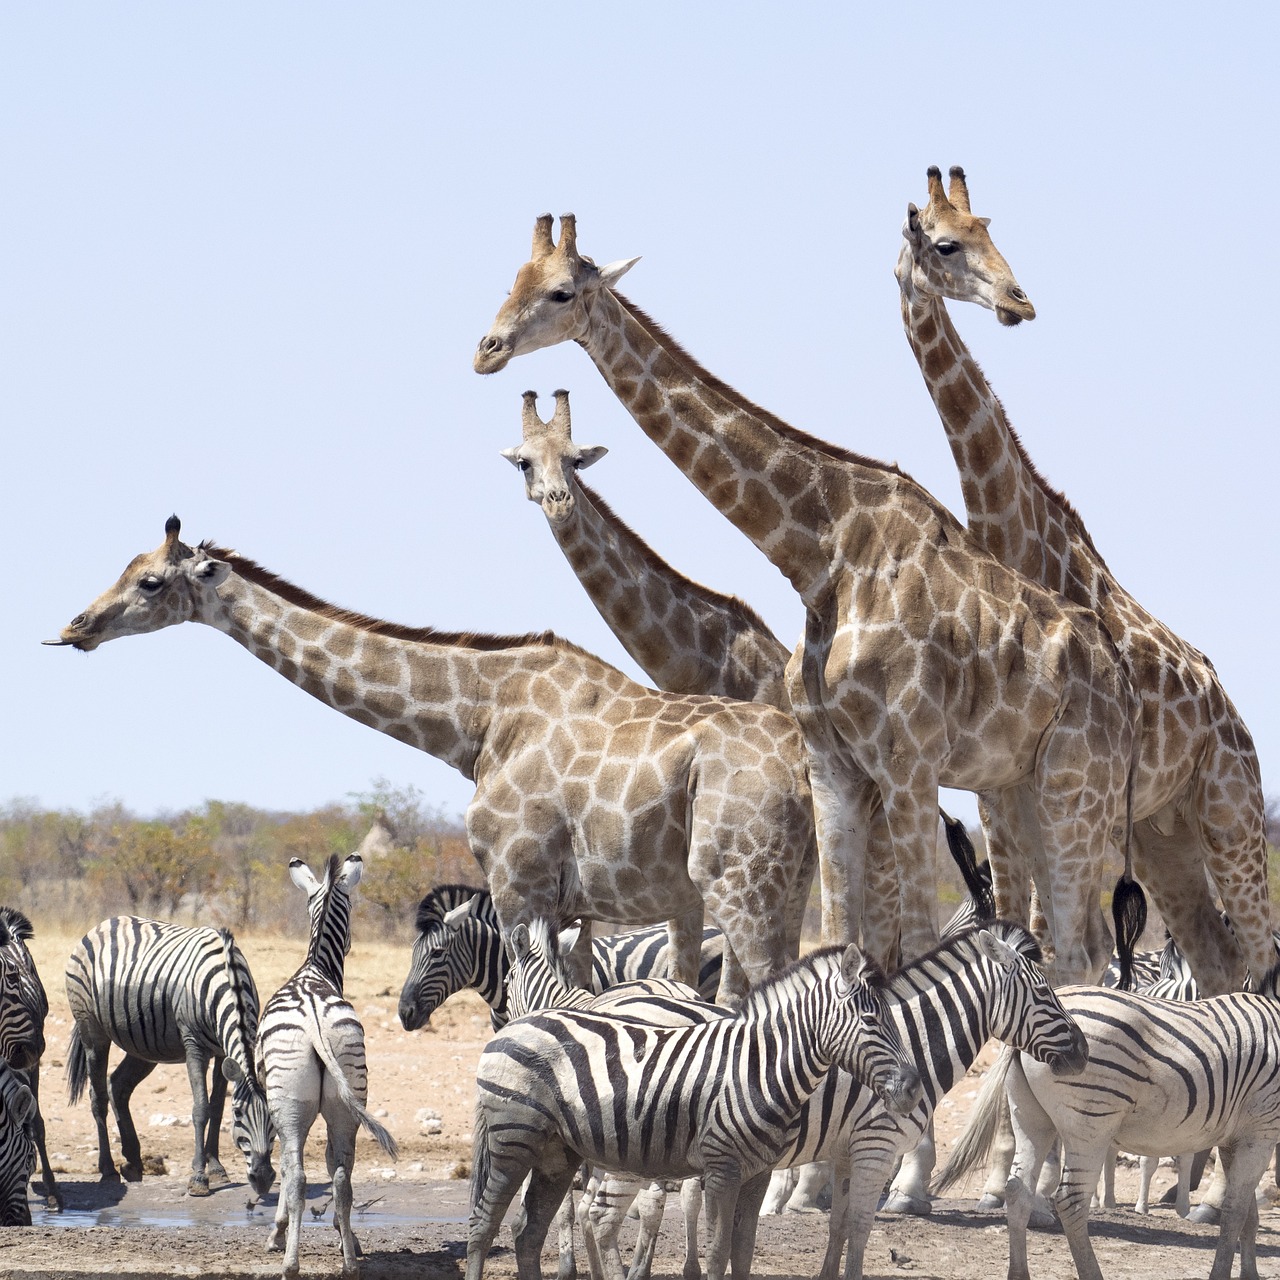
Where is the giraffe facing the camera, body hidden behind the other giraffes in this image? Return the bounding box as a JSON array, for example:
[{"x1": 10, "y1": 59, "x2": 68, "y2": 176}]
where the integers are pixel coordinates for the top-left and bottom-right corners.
[{"x1": 502, "y1": 390, "x2": 899, "y2": 969}]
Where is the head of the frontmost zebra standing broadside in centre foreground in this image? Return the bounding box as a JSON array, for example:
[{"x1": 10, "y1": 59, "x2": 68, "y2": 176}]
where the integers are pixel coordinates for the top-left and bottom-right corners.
[{"x1": 818, "y1": 943, "x2": 924, "y2": 1115}]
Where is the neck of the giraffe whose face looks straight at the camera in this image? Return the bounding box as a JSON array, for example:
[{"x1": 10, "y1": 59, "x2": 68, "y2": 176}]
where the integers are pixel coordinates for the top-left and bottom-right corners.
[{"x1": 549, "y1": 483, "x2": 790, "y2": 708}]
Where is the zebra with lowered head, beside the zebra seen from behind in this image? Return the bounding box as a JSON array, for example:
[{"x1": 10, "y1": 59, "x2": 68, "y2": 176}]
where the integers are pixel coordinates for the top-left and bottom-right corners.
[{"x1": 67, "y1": 915, "x2": 275, "y2": 1196}]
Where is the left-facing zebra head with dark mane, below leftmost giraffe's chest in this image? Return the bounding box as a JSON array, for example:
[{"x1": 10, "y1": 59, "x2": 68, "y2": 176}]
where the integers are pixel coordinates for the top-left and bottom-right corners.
[{"x1": 399, "y1": 892, "x2": 507, "y2": 1032}]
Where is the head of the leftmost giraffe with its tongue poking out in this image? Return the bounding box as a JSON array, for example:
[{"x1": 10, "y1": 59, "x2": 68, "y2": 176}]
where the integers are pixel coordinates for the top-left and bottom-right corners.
[{"x1": 45, "y1": 516, "x2": 230, "y2": 653}]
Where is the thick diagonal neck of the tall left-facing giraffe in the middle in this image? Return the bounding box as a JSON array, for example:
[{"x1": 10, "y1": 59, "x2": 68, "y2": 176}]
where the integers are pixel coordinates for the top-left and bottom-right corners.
[{"x1": 579, "y1": 288, "x2": 892, "y2": 602}]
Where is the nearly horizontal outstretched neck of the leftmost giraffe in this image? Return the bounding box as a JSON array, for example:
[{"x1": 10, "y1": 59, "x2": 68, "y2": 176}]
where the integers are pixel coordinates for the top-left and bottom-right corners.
[{"x1": 195, "y1": 552, "x2": 499, "y2": 780}]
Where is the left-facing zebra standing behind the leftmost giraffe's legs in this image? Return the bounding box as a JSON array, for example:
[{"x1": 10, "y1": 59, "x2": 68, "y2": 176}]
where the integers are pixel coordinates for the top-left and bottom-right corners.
[{"x1": 399, "y1": 884, "x2": 724, "y2": 1032}]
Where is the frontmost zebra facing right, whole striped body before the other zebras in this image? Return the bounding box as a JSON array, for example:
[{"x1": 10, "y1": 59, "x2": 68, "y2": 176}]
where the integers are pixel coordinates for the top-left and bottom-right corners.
[{"x1": 467, "y1": 946, "x2": 920, "y2": 1280}]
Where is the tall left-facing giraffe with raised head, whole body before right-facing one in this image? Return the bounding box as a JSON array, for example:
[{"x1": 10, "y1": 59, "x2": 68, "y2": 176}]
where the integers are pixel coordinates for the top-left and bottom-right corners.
[{"x1": 474, "y1": 214, "x2": 1135, "y2": 982}]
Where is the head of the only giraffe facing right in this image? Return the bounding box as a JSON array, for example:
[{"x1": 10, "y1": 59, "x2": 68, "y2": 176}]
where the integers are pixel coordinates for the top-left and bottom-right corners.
[{"x1": 895, "y1": 165, "x2": 1036, "y2": 325}]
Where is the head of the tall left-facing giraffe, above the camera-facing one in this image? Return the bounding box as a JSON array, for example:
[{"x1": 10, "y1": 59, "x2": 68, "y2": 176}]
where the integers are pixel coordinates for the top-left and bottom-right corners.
[{"x1": 472, "y1": 214, "x2": 640, "y2": 374}]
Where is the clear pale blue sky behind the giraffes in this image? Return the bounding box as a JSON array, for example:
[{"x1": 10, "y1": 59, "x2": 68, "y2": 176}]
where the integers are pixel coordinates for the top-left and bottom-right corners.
[{"x1": 0, "y1": 3, "x2": 1280, "y2": 829}]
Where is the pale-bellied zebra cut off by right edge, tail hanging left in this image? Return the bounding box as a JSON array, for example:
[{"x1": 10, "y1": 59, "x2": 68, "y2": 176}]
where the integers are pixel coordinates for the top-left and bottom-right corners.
[{"x1": 938, "y1": 966, "x2": 1280, "y2": 1280}]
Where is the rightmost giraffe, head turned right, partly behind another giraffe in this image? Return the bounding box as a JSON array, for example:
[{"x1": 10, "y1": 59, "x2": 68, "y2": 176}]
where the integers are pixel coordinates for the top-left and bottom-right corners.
[{"x1": 896, "y1": 166, "x2": 1276, "y2": 995}]
